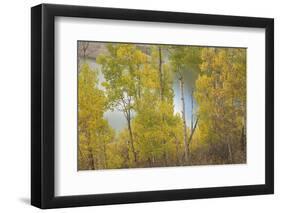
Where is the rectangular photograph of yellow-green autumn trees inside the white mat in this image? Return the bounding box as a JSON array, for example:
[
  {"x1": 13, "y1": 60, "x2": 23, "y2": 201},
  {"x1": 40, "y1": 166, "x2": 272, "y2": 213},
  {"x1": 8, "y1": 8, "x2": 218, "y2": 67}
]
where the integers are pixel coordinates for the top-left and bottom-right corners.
[{"x1": 77, "y1": 40, "x2": 247, "y2": 171}]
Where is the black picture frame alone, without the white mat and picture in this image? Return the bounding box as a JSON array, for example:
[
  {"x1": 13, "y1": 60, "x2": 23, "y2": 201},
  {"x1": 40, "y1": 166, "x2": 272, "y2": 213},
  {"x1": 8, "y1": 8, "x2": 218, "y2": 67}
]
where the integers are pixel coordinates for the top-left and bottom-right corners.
[{"x1": 31, "y1": 4, "x2": 274, "y2": 209}]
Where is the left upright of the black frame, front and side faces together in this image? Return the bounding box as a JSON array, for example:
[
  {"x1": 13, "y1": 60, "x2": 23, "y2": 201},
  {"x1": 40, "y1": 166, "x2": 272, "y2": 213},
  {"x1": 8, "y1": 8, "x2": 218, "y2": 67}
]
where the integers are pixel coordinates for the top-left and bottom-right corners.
[{"x1": 31, "y1": 4, "x2": 54, "y2": 209}]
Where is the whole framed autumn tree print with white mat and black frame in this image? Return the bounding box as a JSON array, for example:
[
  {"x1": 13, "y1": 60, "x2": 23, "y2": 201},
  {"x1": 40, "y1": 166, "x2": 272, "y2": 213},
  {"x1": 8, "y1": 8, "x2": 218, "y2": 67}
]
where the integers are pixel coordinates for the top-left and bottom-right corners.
[{"x1": 31, "y1": 4, "x2": 274, "y2": 208}]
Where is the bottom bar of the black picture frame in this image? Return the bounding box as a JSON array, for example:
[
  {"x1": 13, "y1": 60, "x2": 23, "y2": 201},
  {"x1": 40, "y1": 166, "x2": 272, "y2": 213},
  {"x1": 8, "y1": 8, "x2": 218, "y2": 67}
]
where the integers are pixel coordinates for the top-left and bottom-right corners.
[{"x1": 47, "y1": 184, "x2": 272, "y2": 209}]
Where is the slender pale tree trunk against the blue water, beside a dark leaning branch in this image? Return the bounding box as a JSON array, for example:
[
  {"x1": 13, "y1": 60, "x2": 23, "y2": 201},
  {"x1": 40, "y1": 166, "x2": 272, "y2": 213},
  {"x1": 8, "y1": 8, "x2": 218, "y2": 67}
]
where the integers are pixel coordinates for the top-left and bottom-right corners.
[{"x1": 179, "y1": 76, "x2": 189, "y2": 162}]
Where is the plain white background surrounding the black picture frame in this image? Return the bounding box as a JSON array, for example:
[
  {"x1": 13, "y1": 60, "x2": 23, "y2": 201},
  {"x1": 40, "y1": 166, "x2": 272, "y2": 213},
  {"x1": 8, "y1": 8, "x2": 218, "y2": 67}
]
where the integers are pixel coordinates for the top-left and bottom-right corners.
[{"x1": 0, "y1": 0, "x2": 276, "y2": 213}]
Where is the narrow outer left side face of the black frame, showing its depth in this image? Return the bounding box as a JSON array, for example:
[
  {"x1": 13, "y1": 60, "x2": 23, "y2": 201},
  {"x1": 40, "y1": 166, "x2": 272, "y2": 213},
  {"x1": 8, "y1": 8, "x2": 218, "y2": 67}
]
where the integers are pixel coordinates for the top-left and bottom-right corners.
[{"x1": 31, "y1": 5, "x2": 43, "y2": 208}]
